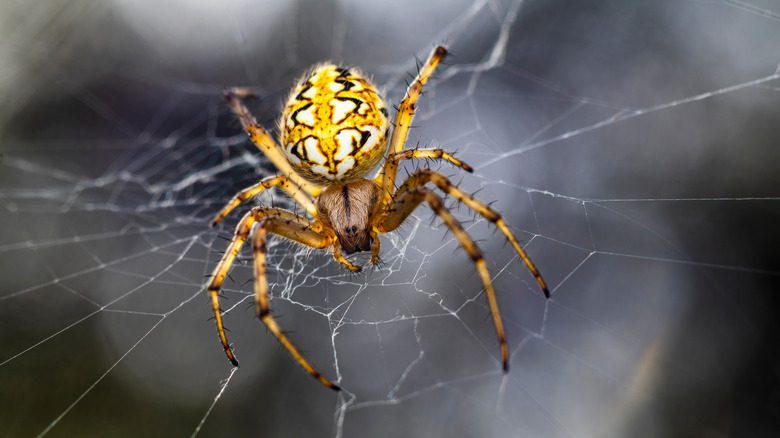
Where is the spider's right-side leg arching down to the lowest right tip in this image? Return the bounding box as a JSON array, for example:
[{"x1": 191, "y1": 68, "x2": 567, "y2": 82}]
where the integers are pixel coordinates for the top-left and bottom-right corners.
[{"x1": 378, "y1": 185, "x2": 509, "y2": 372}]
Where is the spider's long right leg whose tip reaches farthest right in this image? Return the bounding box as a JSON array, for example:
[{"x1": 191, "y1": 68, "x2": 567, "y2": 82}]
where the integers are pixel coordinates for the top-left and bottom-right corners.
[{"x1": 380, "y1": 169, "x2": 550, "y2": 298}]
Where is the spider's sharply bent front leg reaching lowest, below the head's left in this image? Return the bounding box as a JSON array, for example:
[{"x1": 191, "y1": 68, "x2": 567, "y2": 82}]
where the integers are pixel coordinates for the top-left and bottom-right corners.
[{"x1": 252, "y1": 217, "x2": 341, "y2": 391}]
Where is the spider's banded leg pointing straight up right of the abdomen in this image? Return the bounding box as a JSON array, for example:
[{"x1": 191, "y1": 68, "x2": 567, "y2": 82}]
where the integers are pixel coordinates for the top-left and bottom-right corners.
[{"x1": 377, "y1": 46, "x2": 447, "y2": 203}]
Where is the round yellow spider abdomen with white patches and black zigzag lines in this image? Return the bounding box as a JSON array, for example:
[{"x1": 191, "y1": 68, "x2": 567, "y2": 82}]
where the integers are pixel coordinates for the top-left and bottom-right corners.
[{"x1": 279, "y1": 64, "x2": 389, "y2": 184}]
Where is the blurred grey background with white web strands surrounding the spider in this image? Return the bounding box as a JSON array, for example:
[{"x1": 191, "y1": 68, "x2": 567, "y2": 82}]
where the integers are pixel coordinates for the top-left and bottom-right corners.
[{"x1": 0, "y1": 0, "x2": 780, "y2": 437}]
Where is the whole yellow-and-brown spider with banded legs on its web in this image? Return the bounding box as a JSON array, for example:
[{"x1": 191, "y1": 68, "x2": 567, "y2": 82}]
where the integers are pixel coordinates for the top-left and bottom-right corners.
[{"x1": 208, "y1": 47, "x2": 550, "y2": 391}]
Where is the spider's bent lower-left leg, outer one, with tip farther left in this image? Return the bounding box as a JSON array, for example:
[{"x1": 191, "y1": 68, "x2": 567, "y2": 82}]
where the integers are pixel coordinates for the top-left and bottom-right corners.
[{"x1": 208, "y1": 207, "x2": 330, "y2": 366}]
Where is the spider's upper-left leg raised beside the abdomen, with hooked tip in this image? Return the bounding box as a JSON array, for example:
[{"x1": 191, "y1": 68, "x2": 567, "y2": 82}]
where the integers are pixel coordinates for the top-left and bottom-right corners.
[{"x1": 225, "y1": 88, "x2": 322, "y2": 196}]
